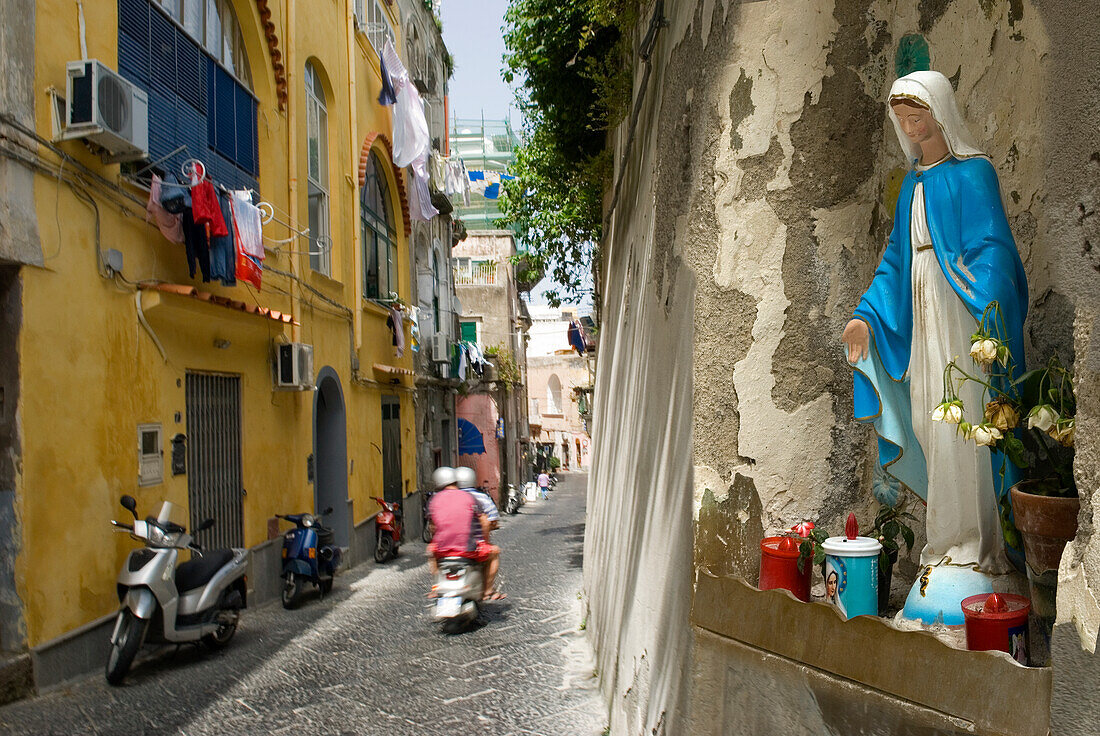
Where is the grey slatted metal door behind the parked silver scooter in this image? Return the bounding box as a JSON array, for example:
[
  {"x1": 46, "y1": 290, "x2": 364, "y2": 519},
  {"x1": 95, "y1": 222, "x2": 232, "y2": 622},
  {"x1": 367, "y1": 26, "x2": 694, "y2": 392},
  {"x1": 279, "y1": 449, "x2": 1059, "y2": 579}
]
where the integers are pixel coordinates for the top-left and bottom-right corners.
[{"x1": 186, "y1": 372, "x2": 244, "y2": 549}]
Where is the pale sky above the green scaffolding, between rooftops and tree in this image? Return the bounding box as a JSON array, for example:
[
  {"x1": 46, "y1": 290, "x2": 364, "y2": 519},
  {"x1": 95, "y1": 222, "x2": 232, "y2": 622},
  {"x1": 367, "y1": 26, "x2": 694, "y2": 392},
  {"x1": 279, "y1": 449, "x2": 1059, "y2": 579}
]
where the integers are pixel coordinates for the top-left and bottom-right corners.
[{"x1": 442, "y1": 0, "x2": 519, "y2": 127}]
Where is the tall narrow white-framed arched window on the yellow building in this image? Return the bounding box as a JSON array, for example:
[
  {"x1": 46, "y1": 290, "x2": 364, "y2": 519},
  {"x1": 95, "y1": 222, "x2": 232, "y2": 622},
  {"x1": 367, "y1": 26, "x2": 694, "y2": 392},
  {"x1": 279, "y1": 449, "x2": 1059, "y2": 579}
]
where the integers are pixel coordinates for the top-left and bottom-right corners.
[{"x1": 306, "y1": 62, "x2": 332, "y2": 276}]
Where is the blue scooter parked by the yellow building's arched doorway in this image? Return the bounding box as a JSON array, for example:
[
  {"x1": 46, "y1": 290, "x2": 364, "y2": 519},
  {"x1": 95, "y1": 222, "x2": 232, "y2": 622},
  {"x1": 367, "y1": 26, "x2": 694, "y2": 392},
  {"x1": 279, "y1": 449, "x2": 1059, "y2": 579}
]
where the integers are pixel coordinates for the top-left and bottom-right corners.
[{"x1": 275, "y1": 506, "x2": 340, "y2": 608}]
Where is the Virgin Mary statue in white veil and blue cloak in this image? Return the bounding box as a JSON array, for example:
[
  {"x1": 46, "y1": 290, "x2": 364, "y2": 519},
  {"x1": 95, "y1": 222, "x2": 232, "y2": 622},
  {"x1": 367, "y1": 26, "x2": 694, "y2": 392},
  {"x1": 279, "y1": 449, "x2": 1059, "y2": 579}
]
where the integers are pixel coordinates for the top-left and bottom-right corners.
[{"x1": 843, "y1": 72, "x2": 1027, "y2": 574}]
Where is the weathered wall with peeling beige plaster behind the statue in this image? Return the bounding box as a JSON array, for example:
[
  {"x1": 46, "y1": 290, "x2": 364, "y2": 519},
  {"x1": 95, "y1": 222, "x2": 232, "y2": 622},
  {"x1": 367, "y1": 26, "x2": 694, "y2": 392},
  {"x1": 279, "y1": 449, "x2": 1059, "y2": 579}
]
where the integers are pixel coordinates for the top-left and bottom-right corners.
[{"x1": 586, "y1": 0, "x2": 1100, "y2": 734}]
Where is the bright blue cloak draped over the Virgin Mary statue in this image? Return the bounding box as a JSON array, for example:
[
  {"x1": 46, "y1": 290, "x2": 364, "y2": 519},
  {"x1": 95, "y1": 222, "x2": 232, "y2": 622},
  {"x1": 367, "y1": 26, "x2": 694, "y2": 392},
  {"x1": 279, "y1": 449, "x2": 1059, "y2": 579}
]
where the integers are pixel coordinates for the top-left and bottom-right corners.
[{"x1": 854, "y1": 156, "x2": 1027, "y2": 502}]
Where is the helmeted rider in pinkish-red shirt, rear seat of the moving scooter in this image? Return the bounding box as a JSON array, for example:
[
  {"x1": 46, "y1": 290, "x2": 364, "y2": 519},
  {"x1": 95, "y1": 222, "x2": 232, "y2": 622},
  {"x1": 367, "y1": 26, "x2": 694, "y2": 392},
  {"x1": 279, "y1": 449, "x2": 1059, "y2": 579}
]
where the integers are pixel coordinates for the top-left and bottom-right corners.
[{"x1": 428, "y1": 466, "x2": 492, "y2": 597}]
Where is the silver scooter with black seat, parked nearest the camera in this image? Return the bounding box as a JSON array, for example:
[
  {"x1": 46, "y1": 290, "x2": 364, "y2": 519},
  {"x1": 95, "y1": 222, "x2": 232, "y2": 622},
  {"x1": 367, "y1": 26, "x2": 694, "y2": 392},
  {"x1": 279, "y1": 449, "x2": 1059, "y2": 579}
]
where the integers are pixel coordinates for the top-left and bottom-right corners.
[{"x1": 107, "y1": 496, "x2": 248, "y2": 685}]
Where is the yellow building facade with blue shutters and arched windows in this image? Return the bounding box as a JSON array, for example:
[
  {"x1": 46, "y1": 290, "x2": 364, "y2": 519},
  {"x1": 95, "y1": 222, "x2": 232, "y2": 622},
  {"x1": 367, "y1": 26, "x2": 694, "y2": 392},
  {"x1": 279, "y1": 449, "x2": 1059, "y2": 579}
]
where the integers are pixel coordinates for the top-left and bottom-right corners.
[{"x1": 0, "y1": 0, "x2": 417, "y2": 681}]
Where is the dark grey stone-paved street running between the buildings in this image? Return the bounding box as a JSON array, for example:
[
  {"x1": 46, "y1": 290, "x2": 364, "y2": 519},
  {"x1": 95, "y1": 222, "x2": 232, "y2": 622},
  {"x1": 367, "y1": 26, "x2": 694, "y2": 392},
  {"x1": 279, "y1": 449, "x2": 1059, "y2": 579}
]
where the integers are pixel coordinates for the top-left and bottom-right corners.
[{"x1": 0, "y1": 473, "x2": 607, "y2": 736}]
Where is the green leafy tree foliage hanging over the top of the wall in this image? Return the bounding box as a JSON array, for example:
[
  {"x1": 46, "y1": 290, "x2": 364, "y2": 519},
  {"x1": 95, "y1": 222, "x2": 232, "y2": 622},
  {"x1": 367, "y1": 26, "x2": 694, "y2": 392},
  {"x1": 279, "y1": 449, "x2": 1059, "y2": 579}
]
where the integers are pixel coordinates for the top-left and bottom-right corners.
[{"x1": 501, "y1": 0, "x2": 639, "y2": 303}]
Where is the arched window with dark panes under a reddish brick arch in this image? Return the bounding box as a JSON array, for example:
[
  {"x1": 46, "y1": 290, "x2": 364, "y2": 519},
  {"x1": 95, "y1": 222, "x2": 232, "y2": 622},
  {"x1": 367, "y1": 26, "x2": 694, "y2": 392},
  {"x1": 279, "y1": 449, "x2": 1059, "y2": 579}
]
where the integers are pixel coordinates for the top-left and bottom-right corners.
[{"x1": 359, "y1": 151, "x2": 397, "y2": 299}]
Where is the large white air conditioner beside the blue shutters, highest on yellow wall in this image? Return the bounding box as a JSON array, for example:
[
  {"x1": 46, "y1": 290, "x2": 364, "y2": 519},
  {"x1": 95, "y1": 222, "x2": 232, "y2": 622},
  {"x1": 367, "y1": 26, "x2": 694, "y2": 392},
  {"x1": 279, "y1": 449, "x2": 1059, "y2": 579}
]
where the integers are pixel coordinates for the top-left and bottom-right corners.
[{"x1": 64, "y1": 59, "x2": 149, "y2": 162}]
